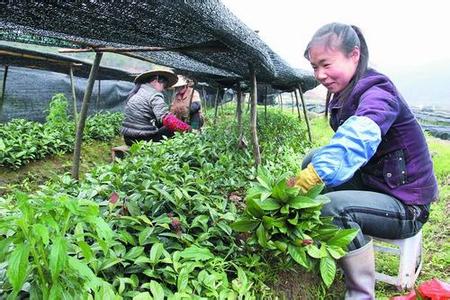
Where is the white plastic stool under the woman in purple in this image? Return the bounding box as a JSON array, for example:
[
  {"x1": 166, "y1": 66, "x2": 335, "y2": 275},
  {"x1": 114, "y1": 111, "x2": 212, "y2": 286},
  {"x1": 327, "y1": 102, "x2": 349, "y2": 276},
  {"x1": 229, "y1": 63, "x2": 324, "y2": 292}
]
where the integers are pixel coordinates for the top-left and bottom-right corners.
[{"x1": 372, "y1": 230, "x2": 422, "y2": 290}]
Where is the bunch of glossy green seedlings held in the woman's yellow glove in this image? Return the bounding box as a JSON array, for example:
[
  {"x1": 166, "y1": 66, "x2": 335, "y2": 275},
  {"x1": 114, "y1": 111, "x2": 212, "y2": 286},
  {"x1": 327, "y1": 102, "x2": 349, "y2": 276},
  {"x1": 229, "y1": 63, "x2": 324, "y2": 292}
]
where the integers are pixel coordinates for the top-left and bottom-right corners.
[{"x1": 231, "y1": 168, "x2": 357, "y2": 287}]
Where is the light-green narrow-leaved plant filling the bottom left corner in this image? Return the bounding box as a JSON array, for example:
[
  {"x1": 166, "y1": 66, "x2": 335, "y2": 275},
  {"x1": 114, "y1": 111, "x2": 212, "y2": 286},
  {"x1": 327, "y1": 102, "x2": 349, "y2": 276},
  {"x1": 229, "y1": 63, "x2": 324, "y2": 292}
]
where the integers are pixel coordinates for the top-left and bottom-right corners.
[{"x1": 0, "y1": 193, "x2": 118, "y2": 299}]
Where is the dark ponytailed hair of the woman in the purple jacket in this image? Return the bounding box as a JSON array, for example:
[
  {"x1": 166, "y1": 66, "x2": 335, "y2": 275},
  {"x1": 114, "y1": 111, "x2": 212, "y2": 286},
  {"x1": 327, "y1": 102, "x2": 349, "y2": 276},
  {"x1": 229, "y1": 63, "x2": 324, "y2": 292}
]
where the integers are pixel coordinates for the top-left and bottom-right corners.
[{"x1": 303, "y1": 23, "x2": 369, "y2": 99}]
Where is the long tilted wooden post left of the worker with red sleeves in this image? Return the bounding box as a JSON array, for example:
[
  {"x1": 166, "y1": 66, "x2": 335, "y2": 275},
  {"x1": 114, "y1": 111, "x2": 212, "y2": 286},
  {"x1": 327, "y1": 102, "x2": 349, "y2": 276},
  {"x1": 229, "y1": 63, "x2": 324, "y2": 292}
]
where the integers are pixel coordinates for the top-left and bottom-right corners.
[{"x1": 72, "y1": 52, "x2": 103, "y2": 180}]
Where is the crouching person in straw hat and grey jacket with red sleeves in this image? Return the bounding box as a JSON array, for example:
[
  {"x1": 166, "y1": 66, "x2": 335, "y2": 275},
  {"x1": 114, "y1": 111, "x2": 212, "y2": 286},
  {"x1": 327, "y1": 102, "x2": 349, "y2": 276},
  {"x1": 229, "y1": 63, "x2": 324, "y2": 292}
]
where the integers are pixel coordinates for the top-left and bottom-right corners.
[{"x1": 120, "y1": 70, "x2": 191, "y2": 146}]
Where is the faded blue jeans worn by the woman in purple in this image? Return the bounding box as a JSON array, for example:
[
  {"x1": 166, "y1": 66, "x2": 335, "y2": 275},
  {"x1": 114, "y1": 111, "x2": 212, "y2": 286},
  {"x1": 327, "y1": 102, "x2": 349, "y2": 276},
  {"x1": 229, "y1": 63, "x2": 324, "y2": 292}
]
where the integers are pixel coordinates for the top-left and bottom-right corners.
[{"x1": 302, "y1": 149, "x2": 429, "y2": 251}]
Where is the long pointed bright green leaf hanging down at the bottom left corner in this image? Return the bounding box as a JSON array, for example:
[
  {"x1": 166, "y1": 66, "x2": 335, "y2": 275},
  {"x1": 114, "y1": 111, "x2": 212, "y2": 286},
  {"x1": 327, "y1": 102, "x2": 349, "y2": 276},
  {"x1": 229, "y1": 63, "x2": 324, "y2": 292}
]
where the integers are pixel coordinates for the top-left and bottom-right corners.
[{"x1": 6, "y1": 244, "x2": 30, "y2": 298}]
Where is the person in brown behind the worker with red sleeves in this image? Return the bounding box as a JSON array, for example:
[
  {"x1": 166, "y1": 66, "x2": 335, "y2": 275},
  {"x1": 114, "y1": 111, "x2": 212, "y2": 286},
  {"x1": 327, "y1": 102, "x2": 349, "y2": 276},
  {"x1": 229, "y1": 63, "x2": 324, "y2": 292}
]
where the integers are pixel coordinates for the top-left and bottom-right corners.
[{"x1": 170, "y1": 76, "x2": 204, "y2": 129}]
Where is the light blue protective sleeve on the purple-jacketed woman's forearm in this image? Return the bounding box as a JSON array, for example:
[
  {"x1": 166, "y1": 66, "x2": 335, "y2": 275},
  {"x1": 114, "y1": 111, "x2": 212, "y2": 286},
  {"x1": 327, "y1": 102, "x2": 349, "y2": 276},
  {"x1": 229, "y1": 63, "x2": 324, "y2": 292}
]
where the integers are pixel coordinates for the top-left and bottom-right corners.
[{"x1": 311, "y1": 116, "x2": 381, "y2": 187}]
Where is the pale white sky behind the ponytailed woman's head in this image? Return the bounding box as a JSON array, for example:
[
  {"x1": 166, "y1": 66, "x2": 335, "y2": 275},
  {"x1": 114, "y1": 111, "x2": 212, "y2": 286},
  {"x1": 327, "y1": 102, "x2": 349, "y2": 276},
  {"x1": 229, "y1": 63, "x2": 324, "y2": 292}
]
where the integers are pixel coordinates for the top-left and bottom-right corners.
[{"x1": 222, "y1": 0, "x2": 450, "y2": 74}]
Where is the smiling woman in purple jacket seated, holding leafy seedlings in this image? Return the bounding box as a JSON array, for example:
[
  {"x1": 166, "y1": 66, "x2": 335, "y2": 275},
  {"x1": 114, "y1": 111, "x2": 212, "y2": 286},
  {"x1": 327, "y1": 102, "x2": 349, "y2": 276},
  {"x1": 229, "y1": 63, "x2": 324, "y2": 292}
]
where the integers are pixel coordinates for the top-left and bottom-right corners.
[{"x1": 293, "y1": 23, "x2": 438, "y2": 299}]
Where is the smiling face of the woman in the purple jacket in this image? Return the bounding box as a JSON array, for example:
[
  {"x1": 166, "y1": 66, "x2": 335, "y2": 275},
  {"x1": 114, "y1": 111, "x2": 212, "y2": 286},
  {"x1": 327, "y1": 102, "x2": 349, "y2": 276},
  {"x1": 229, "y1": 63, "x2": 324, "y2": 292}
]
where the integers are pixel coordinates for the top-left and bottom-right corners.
[{"x1": 309, "y1": 43, "x2": 360, "y2": 93}]
